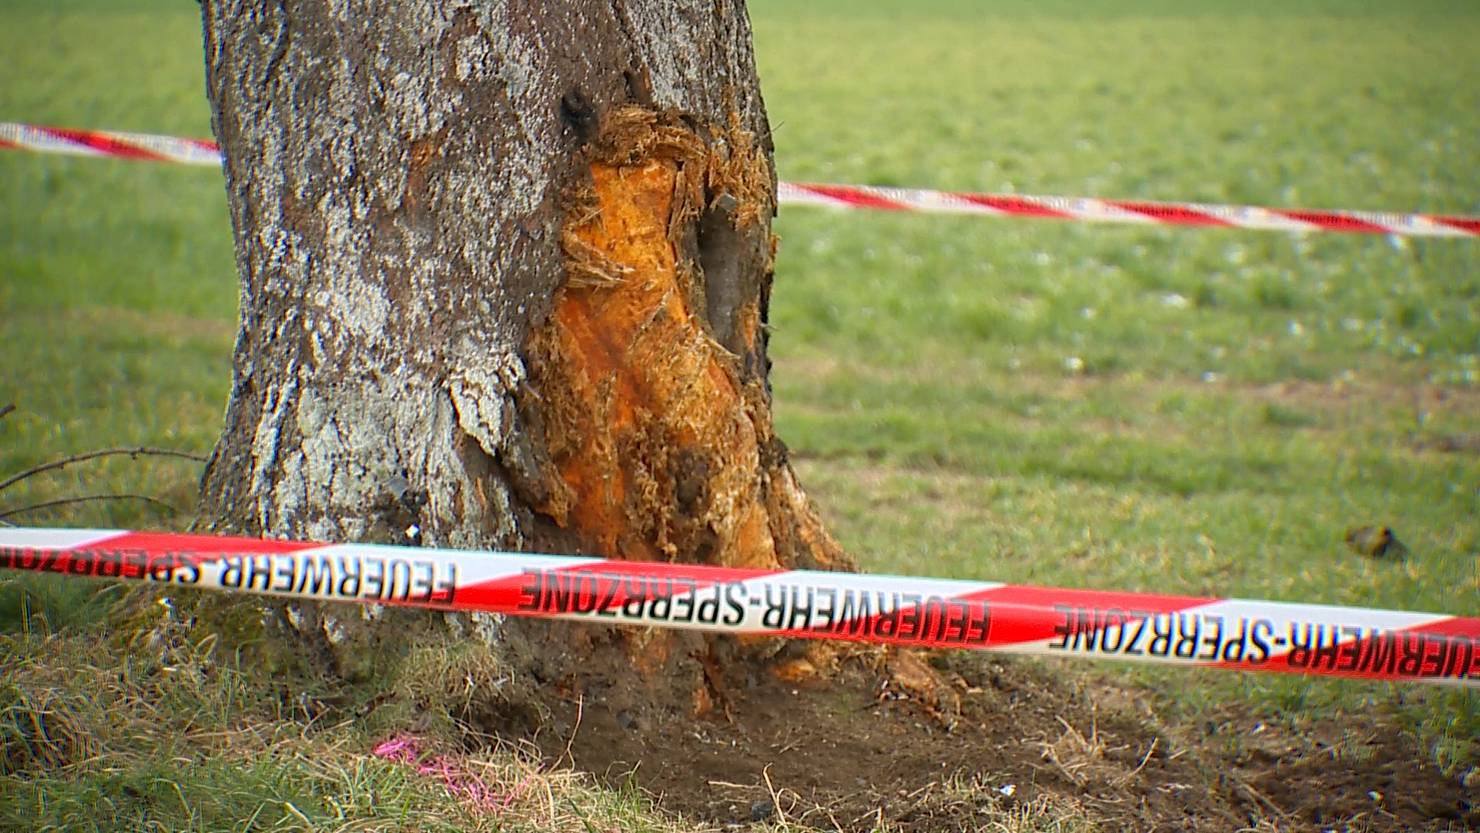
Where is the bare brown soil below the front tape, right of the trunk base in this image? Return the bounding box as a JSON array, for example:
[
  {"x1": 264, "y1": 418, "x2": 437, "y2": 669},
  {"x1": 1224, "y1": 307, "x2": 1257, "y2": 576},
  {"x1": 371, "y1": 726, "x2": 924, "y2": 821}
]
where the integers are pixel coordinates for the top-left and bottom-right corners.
[{"x1": 518, "y1": 654, "x2": 1480, "y2": 832}]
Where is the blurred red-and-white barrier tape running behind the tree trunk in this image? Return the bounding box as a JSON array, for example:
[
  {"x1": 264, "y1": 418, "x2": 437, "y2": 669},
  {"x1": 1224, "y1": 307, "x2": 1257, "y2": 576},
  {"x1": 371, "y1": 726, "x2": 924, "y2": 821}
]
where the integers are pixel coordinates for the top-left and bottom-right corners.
[{"x1": 0, "y1": 123, "x2": 1480, "y2": 238}]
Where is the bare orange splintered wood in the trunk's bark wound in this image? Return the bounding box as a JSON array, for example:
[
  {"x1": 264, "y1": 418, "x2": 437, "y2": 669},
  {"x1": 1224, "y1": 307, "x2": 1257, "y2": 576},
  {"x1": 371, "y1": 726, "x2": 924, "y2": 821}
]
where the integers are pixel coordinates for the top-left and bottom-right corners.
[{"x1": 528, "y1": 108, "x2": 778, "y2": 568}]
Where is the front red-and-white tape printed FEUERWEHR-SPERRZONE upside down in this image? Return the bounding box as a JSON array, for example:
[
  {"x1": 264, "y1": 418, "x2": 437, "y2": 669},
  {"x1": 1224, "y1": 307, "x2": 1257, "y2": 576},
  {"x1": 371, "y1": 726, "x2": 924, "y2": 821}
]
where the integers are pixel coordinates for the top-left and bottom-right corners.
[{"x1": 0, "y1": 528, "x2": 1480, "y2": 687}]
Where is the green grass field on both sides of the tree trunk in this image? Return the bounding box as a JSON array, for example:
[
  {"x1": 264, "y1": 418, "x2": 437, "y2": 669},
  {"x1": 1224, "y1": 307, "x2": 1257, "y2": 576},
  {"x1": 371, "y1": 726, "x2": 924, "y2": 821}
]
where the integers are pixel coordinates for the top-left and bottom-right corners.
[{"x1": 0, "y1": 0, "x2": 1480, "y2": 830}]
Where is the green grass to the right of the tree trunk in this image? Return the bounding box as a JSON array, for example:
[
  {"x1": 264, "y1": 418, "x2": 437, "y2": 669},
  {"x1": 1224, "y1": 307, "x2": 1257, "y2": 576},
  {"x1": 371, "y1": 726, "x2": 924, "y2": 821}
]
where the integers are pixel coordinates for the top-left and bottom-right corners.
[{"x1": 752, "y1": 0, "x2": 1480, "y2": 762}]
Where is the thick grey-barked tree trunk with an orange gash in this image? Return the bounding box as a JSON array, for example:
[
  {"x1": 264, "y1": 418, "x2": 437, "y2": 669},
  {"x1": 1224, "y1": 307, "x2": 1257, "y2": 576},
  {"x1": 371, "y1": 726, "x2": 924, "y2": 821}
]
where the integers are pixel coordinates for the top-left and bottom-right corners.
[{"x1": 201, "y1": 0, "x2": 850, "y2": 712}]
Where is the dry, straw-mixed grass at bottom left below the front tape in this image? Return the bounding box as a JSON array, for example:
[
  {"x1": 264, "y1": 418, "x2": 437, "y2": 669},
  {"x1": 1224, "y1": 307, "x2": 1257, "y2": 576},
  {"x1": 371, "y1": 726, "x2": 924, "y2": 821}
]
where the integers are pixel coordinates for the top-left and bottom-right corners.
[{"x1": 0, "y1": 630, "x2": 694, "y2": 832}]
